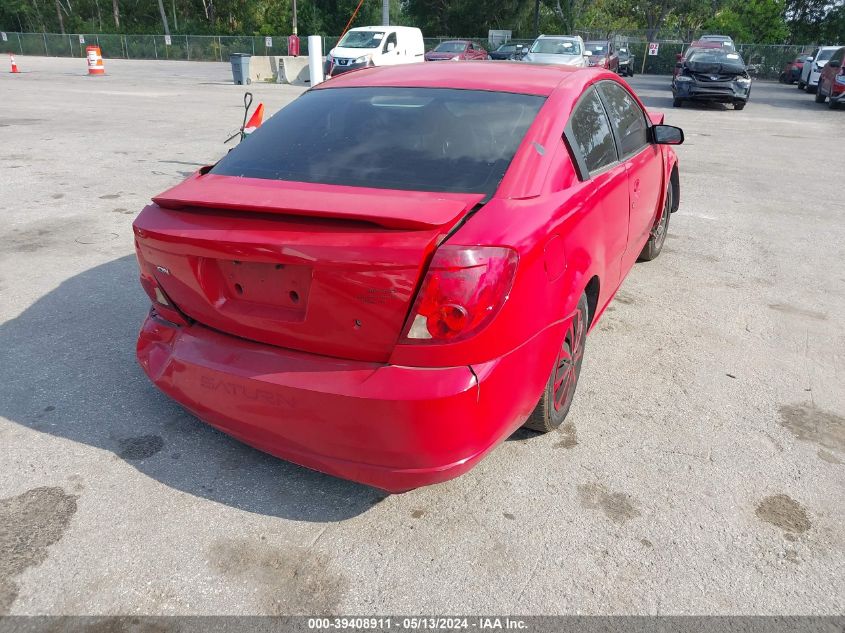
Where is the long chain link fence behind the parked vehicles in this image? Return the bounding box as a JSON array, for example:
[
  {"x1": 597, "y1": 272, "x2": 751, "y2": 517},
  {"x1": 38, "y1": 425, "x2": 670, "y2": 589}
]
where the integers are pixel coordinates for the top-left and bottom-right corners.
[{"x1": 0, "y1": 31, "x2": 812, "y2": 79}]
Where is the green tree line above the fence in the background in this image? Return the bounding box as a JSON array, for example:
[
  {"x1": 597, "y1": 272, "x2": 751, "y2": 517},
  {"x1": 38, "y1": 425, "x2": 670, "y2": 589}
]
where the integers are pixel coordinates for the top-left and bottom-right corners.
[{"x1": 0, "y1": 0, "x2": 845, "y2": 44}]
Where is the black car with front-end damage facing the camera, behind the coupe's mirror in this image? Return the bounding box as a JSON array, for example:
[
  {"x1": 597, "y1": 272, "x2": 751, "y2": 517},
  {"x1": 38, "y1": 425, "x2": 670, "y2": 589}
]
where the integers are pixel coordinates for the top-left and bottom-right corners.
[{"x1": 672, "y1": 48, "x2": 751, "y2": 110}]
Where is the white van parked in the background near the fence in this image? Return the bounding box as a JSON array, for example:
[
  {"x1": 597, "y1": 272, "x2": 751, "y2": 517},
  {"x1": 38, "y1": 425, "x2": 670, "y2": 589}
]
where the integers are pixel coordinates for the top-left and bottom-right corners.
[{"x1": 326, "y1": 26, "x2": 425, "y2": 77}]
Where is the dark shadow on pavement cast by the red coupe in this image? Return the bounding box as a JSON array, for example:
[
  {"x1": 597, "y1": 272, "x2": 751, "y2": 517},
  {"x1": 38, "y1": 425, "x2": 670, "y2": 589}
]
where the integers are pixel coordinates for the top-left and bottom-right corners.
[{"x1": 0, "y1": 256, "x2": 385, "y2": 522}]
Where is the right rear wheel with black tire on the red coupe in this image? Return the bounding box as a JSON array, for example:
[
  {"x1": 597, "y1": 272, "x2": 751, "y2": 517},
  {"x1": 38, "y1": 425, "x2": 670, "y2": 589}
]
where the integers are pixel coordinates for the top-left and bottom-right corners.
[{"x1": 523, "y1": 294, "x2": 590, "y2": 433}]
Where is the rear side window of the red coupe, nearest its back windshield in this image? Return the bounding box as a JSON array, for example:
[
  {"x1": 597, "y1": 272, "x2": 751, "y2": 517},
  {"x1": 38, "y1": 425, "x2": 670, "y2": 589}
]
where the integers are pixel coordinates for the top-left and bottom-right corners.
[{"x1": 565, "y1": 88, "x2": 618, "y2": 180}]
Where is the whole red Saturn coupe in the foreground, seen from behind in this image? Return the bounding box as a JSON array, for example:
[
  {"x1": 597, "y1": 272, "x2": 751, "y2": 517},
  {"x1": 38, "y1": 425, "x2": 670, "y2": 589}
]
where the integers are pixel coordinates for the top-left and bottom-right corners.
[{"x1": 134, "y1": 62, "x2": 683, "y2": 492}]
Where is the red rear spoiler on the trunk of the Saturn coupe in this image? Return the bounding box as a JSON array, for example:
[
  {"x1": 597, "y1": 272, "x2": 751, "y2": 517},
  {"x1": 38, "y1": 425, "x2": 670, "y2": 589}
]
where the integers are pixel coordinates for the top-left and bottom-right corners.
[{"x1": 153, "y1": 170, "x2": 484, "y2": 229}]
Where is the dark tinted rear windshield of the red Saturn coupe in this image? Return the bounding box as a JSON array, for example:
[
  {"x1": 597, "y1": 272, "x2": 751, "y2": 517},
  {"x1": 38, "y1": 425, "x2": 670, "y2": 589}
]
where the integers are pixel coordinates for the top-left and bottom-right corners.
[{"x1": 210, "y1": 87, "x2": 545, "y2": 195}]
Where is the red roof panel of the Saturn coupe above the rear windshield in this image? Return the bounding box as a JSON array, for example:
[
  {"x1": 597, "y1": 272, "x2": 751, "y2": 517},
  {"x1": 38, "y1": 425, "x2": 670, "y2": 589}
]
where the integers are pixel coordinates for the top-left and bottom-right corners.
[{"x1": 315, "y1": 61, "x2": 598, "y2": 96}]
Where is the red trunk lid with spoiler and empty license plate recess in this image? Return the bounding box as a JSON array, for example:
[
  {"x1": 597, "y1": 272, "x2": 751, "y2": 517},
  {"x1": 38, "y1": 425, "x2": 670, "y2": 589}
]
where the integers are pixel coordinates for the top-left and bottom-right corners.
[{"x1": 134, "y1": 175, "x2": 482, "y2": 362}]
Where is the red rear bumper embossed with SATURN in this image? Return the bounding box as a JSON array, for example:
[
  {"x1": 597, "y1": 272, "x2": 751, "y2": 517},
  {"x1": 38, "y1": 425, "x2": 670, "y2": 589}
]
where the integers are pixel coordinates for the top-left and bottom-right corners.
[{"x1": 137, "y1": 313, "x2": 554, "y2": 492}]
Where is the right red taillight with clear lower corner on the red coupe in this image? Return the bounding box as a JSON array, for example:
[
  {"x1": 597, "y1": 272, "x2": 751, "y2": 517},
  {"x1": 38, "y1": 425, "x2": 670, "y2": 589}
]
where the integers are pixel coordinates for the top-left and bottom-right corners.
[{"x1": 402, "y1": 244, "x2": 519, "y2": 343}]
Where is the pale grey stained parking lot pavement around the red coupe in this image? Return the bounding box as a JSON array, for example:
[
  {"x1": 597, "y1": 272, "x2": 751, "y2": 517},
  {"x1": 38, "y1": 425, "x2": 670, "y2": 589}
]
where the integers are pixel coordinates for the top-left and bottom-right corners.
[{"x1": 0, "y1": 57, "x2": 845, "y2": 615}]
